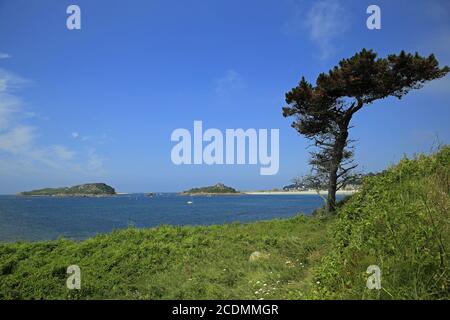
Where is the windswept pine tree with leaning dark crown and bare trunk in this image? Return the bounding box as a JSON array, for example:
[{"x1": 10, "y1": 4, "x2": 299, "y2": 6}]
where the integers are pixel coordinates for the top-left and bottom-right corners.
[{"x1": 283, "y1": 49, "x2": 450, "y2": 213}]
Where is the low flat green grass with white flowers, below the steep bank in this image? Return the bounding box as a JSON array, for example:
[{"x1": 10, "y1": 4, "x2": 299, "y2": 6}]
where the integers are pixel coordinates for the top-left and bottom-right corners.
[{"x1": 0, "y1": 215, "x2": 330, "y2": 299}]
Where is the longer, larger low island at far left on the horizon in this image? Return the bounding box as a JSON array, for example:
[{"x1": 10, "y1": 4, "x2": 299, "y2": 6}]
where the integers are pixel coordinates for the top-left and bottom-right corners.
[{"x1": 19, "y1": 183, "x2": 116, "y2": 197}]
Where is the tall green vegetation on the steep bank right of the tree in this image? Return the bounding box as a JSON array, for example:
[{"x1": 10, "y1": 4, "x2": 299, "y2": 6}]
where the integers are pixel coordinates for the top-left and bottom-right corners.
[{"x1": 313, "y1": 147, "x2": 450, "y2": 299}]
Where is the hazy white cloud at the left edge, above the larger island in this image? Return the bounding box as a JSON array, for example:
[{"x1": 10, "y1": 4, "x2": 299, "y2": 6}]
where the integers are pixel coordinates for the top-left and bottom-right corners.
[{"x1": 0, "y1": 69, "x2": 103, "y2": 180}]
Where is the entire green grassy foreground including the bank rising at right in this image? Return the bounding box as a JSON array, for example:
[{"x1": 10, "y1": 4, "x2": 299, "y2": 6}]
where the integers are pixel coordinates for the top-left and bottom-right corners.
[{"x1": 0, "y1": 147, "x2": 450, "y2": 299}]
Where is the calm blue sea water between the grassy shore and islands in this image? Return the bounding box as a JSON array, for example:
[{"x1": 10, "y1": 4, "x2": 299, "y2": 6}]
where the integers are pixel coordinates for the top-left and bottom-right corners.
[{"x1": 0, "y1": 194, "x2": 340, "y2": 241}]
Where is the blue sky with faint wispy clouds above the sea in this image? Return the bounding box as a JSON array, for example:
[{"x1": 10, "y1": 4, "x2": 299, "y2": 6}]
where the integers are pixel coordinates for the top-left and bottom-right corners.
[{"x1": 0, "y1": 0, "x2": 450, "y2": 194}]
